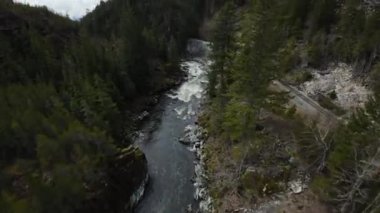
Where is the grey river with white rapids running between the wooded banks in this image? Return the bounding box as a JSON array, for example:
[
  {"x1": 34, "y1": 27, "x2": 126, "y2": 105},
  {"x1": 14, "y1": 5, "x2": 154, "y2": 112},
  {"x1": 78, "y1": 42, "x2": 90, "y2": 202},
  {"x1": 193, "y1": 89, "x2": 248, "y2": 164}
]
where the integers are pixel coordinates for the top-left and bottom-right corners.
[{"x1": 136, "y1": 40, "x2": 209, "y2": 213}]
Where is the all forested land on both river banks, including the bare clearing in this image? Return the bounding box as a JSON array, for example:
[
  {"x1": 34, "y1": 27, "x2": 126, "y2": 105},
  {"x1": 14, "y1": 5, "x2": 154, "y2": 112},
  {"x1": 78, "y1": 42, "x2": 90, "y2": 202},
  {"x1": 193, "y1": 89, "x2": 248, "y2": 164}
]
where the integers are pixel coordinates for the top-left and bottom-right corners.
[{"x1": 0, "y1": 0, "x2": 380, "y2": 213}]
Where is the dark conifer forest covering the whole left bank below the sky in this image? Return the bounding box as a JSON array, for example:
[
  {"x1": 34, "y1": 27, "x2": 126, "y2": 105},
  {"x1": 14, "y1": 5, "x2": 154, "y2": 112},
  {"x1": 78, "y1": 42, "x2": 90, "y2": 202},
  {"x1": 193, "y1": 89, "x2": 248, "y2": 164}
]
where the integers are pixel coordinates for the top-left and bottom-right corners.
[{"x1": 0, "y1": 0, "x2": 202, "y2": 213}]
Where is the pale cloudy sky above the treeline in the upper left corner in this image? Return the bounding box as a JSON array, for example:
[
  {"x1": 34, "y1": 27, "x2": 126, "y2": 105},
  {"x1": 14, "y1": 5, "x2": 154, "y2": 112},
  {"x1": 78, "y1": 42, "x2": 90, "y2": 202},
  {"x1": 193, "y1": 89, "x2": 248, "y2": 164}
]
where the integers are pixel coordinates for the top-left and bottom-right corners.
[{"x1": 14, "y1": 0, "x2": 105, "y2": 19}]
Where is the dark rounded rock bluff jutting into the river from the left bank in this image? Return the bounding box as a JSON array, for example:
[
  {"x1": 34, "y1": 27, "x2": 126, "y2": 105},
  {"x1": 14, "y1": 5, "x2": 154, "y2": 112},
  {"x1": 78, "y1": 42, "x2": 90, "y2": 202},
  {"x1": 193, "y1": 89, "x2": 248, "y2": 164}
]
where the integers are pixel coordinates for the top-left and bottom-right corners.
[{"x1": 81, "y1": 146, "x2": 148, "y2": 213}]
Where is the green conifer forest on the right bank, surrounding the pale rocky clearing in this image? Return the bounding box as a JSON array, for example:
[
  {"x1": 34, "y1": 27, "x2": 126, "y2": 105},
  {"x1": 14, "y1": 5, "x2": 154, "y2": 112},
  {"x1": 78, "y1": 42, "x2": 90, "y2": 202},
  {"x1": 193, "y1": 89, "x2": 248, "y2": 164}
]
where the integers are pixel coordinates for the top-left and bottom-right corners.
[{"x1": 203, "y1": 0, "x2": 380, "y2": 212}]
